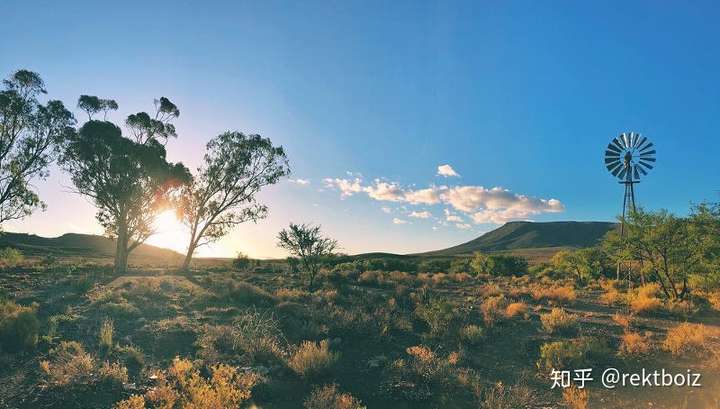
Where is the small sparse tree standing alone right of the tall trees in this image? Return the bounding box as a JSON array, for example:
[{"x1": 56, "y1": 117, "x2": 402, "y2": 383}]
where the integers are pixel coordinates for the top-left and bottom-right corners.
[{"x1": 278, "y1": 223, "x2": 337, "y2": 289}]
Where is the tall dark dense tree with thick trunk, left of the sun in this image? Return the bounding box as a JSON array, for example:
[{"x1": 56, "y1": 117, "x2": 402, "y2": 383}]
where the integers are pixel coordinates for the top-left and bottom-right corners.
[{"x1": 60, "y1": 98, "x2": 190, "y2": 273}]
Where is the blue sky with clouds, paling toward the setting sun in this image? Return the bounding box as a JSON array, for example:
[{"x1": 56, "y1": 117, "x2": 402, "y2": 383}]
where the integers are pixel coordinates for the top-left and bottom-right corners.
[{"x1": 0, "y1": 0, "x2": 720, "y2": 258}]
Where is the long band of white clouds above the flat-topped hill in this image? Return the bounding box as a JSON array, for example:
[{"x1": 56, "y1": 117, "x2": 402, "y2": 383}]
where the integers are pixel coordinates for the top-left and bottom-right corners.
[{"x1": 324, "y1": 177, "x2": 565, "y2": 228}]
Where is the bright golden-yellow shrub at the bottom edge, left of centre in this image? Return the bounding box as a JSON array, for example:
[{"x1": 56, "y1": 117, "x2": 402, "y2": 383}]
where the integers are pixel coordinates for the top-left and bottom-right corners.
[{"x1": 134, "y1": 358, "x2": 259, "y2": 409}]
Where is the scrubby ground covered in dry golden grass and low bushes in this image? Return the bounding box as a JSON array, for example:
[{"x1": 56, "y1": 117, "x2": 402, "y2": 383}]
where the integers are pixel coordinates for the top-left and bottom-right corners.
[{"x1": 0, "y1": 260, "x2": 720, "y2": 409}]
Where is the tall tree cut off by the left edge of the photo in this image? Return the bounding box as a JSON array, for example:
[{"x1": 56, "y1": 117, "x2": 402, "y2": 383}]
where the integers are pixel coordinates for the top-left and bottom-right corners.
[{"x1": 0, "y1": 70, "x2": 75, "y2": 224}]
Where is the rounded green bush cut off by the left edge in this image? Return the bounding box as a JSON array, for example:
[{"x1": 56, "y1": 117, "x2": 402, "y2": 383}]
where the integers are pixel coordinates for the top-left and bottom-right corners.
[{"x1": 0, "y1": 301, "x2": 40, "y2": 352}]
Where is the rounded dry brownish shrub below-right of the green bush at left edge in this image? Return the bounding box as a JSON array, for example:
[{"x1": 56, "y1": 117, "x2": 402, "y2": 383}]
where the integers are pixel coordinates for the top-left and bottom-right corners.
[{"x1": 40, "y1": 341, "x2": 95, "y2": 386}]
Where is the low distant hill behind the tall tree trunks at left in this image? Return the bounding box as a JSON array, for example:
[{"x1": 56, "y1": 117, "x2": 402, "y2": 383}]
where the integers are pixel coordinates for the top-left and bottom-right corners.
[{"x1": 0, "y1": 232, "x2": 181, "y2": 259}]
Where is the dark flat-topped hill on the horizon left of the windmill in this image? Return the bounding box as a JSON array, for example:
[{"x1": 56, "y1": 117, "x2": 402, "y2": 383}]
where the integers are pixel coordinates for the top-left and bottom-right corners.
[{"x1": 418, "y1": 222, "x2": 617, "y2": 256}]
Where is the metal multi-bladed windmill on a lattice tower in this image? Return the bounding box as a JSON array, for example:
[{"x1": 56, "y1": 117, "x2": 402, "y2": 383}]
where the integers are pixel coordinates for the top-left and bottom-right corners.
[{"x1": 605, "y1": 132, "x2": 656, "y2": 279}]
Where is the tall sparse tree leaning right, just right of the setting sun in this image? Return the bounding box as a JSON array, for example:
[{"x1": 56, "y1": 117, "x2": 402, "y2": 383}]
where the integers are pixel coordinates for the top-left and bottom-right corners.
[{"x1": 179, "y1": 132, "x2": 290, "y2": 270}]
